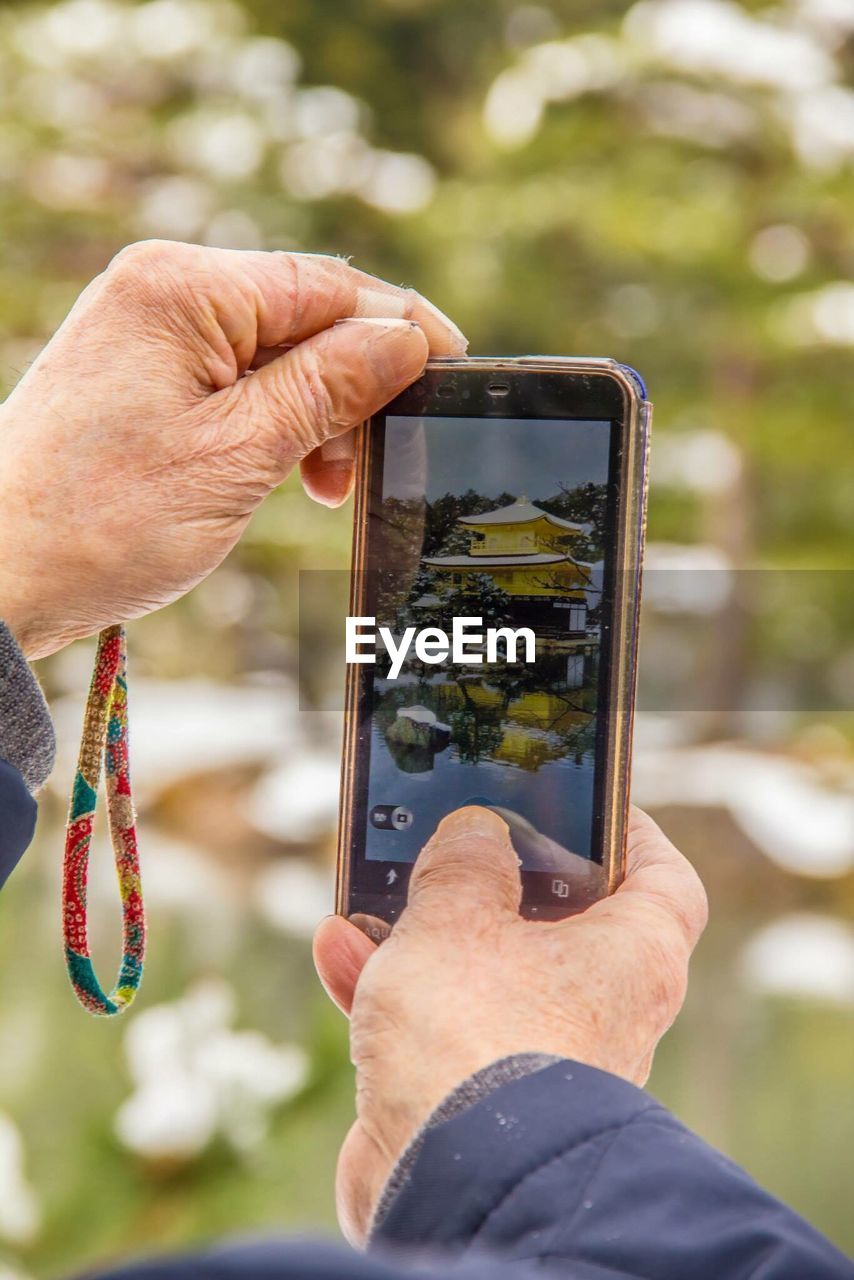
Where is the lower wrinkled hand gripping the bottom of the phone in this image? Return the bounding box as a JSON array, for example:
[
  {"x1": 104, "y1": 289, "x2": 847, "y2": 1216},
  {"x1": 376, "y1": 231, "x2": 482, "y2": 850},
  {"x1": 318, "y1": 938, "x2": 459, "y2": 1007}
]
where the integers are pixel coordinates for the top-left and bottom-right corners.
[{"x1": 315, "y1": 808, "x2": 707, "y2": 1243}]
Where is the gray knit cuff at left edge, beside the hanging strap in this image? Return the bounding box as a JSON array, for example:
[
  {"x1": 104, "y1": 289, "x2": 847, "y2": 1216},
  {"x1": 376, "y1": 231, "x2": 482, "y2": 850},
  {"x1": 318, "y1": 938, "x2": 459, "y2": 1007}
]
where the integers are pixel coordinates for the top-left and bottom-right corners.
[{"x1": 0, "y1": 622, "x2": 56, "y2": 791}]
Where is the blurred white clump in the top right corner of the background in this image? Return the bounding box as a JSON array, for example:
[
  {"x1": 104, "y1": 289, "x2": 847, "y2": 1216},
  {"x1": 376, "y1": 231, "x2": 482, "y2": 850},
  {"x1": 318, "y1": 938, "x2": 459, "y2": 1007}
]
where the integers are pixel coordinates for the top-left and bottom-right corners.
[{"x1": 483, "y1": 0, "x2": 854, "y2": 169}]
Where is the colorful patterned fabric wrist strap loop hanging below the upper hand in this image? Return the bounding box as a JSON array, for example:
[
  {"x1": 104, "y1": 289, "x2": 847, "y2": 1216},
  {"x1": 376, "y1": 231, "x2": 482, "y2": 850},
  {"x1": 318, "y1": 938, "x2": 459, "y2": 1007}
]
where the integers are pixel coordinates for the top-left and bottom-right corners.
[{"x1": 63, "y1": 626, "x2": 145, "y2": 1016}]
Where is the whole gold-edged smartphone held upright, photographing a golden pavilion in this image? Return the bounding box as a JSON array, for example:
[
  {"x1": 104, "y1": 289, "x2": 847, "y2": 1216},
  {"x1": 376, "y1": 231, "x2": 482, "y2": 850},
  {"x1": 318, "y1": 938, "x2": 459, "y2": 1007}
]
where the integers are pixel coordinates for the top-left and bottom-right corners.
[{"x1": 337, "y1": 356, "x2": 652, "y2": 938}]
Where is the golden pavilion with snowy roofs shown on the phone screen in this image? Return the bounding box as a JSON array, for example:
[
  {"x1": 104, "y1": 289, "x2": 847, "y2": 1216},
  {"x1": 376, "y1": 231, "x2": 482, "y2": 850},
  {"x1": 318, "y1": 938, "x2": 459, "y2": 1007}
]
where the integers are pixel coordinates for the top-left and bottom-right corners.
[{"x1": 423, "y1": 495, "x2": 592, "y2": 635}]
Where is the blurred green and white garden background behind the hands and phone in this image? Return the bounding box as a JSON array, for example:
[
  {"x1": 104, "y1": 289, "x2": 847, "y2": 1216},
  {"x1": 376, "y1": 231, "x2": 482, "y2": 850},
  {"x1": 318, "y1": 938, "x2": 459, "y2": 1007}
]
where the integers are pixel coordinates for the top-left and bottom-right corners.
[{"x1": 0, "y1": 0, "x2": 854, "y2": 1280}]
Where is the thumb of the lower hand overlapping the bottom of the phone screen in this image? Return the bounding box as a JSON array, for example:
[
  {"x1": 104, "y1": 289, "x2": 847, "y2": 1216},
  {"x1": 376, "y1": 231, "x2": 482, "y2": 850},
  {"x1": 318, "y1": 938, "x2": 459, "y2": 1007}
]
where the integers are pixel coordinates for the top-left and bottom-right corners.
[{"x1": 408, "y1": 805, "x2": 521, "y2": 922}]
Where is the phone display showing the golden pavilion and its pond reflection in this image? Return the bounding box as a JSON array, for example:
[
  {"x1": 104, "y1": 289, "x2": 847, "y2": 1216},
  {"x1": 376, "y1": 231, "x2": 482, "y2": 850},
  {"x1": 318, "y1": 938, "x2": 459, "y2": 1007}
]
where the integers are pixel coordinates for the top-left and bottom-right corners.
[{"x1": 351, "y1": 413, "x2": 620, "y2": 920}]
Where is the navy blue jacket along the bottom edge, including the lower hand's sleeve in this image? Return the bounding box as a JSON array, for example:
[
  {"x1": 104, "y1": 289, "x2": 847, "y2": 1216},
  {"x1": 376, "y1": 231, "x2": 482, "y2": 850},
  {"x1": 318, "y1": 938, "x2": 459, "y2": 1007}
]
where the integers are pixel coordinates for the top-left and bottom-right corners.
[{"x1": 85, "y1": 1061, "x2": 854, "y2": 1280}]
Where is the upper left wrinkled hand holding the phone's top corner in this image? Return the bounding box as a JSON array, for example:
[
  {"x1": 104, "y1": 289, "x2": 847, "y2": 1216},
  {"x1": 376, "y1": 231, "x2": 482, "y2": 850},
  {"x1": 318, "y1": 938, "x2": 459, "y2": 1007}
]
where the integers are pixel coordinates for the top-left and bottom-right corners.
[{"x1": 0, "y1": 241, "x2": 465, "y2": 657}]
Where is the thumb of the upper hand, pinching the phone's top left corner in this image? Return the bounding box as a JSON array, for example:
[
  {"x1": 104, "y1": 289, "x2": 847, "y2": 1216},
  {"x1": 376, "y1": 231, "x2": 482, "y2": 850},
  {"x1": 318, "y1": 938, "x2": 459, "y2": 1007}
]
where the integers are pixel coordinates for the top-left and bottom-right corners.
[{"x1": 229, "y1": 319, "x2": 428, "y2": 485}]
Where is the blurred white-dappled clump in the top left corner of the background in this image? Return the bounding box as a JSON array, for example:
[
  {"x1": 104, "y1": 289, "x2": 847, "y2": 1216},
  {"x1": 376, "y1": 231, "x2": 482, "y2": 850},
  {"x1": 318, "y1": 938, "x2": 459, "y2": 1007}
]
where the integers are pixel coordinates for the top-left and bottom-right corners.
[{"x1": 0, "y1": 0, "x2": 435, "y2": 226}]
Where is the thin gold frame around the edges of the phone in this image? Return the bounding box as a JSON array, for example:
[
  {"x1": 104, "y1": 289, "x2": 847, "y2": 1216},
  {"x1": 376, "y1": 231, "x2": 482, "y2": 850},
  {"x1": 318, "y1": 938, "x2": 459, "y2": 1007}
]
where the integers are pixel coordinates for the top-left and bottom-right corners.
[{"x1": 335, "y1": 356, "x2": 653, "y2": 915}]
